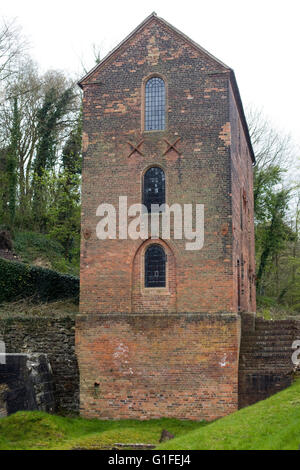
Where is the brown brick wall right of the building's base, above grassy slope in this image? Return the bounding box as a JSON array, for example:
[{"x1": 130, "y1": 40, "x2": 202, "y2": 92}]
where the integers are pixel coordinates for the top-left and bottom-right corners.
[{"x1": 239, "y1": 314, "x2": 300, "y2": 408}]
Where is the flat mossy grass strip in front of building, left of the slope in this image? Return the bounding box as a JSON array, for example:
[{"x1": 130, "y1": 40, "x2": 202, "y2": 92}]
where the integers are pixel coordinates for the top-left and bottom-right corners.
[{"x1": 0, "y1": 411, "x2": 205, "y2": 450}]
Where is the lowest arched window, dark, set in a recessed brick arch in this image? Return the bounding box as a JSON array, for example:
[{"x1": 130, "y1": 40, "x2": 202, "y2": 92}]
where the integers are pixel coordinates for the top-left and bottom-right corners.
[{"x1": 145, "y1": 245, "x2": 166, "y2": 287}]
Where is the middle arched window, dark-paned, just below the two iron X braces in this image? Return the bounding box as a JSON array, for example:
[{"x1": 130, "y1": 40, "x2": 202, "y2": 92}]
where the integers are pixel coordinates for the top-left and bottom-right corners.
[{"x1": 143, "y1": 166, "x2": 166, "y2": 212}]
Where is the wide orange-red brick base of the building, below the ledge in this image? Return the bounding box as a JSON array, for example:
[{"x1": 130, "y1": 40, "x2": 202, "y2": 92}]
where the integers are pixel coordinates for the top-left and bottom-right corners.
[{"x1": 76, "y1": 313, "x2": 240, "y2": 420}]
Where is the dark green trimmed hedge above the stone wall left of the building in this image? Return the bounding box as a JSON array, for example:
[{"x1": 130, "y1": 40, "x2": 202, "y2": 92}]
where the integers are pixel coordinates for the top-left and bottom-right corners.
[{"x1": 0, "y1": 259, "x2": 79, "y2": 303}]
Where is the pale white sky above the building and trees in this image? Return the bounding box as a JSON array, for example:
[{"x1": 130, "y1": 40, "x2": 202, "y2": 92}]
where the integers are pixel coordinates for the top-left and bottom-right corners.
[{"x1": 0, "y1": 0, "x2": 300, "y2": 145}]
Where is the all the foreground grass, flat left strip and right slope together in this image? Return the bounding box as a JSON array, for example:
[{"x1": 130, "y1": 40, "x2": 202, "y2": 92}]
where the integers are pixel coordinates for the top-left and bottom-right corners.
[{"x1": 0, "y1": 380, "x2": 300, "y2": 450}]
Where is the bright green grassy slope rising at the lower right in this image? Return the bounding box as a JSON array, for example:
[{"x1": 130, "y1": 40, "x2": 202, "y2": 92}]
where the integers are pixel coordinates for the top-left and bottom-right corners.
[{"x1": 158, "y1": 380, "x2": 300, "y2": 450}]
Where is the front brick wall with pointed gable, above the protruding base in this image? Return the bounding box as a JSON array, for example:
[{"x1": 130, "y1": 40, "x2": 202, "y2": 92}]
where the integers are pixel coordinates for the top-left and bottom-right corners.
[{"x1": 81, "y1": 15, "x2": 242, "y2": 313}]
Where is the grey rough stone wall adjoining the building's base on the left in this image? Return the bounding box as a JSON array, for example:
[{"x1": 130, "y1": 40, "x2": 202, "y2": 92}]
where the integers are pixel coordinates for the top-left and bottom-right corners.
[{"x1": 0, "y1": 316, "x2": 79, "y2": 414}]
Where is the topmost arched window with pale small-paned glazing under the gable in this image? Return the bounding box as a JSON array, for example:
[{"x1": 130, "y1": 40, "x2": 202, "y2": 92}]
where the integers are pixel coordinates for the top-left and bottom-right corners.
[{"x1": 145, "y1": 77, "x2": 166, "y2": 131}]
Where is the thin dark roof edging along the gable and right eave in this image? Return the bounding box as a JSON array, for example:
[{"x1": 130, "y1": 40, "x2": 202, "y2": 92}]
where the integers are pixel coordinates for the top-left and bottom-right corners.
[{"x1": 78, "y1": 12, "x2": 255, "y2": 163}]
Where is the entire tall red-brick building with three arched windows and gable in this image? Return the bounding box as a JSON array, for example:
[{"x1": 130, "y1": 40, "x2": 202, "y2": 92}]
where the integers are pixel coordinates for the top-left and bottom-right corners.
[{"x1": 76, "y1": 13, "x2": 255, "y2": 419}]
